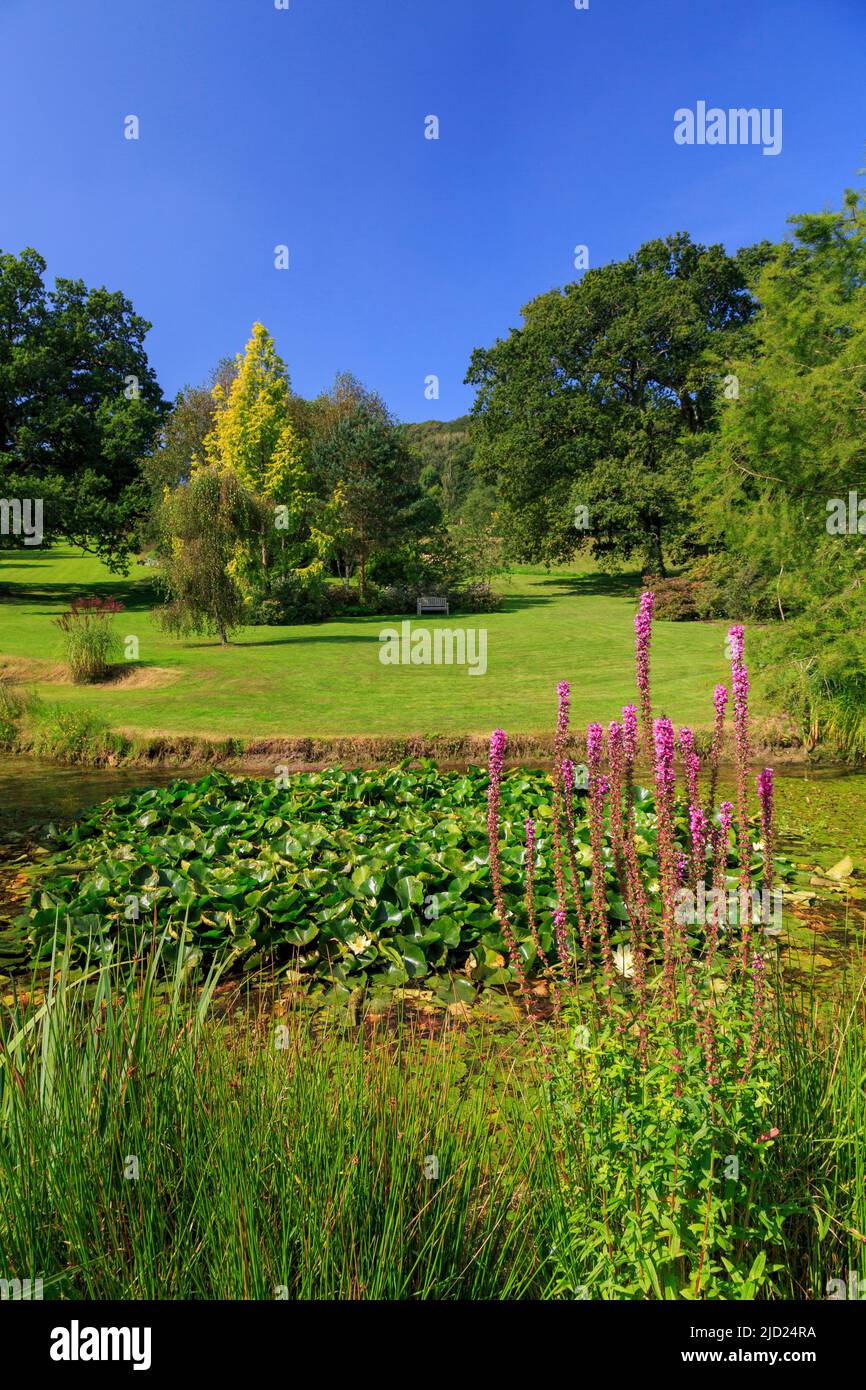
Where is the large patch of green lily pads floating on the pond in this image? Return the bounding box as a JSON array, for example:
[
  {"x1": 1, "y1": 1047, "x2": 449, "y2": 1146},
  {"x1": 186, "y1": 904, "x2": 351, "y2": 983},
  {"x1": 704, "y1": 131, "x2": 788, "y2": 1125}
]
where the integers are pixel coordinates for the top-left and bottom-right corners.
[{"x1": 18, "y1": 763, "x2": 670, "y2": 994}]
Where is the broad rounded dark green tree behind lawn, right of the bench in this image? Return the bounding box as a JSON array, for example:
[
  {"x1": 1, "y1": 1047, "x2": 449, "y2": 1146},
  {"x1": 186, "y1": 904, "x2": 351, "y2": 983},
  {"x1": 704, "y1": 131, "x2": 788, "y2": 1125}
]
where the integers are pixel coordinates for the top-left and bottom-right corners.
[{"x1": 467, "y1": 234, "x2": 767, "y2": 574}]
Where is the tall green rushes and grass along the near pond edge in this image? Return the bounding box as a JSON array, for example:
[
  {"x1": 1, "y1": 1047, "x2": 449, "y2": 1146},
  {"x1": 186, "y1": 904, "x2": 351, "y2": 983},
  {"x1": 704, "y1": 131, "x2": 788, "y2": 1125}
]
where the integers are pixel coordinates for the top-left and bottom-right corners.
[{"x1": 0, "y1": 934, "x2": 866, "y2": 1300}]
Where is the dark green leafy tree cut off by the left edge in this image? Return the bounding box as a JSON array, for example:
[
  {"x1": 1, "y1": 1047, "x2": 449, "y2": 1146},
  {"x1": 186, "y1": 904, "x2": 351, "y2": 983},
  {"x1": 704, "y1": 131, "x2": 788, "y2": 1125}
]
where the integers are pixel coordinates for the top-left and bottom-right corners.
[{"x1": 0, "y1": 249, "x2": 165, "y2": 569}]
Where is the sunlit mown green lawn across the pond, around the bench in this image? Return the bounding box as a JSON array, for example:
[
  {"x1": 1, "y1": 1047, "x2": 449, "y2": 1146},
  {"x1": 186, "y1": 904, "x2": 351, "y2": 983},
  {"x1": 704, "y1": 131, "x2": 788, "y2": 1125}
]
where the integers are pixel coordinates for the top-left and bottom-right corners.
[{"x1": 0, "y1": 548, "x2": 727, "y2": 737}]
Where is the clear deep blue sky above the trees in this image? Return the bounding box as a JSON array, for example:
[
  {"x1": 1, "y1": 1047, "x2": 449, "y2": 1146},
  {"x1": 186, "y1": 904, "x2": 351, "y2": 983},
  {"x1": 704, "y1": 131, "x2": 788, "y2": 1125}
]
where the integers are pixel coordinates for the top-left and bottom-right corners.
[{"x1": 0, "y1": 0, "x2": 866, "y2": 420}]
